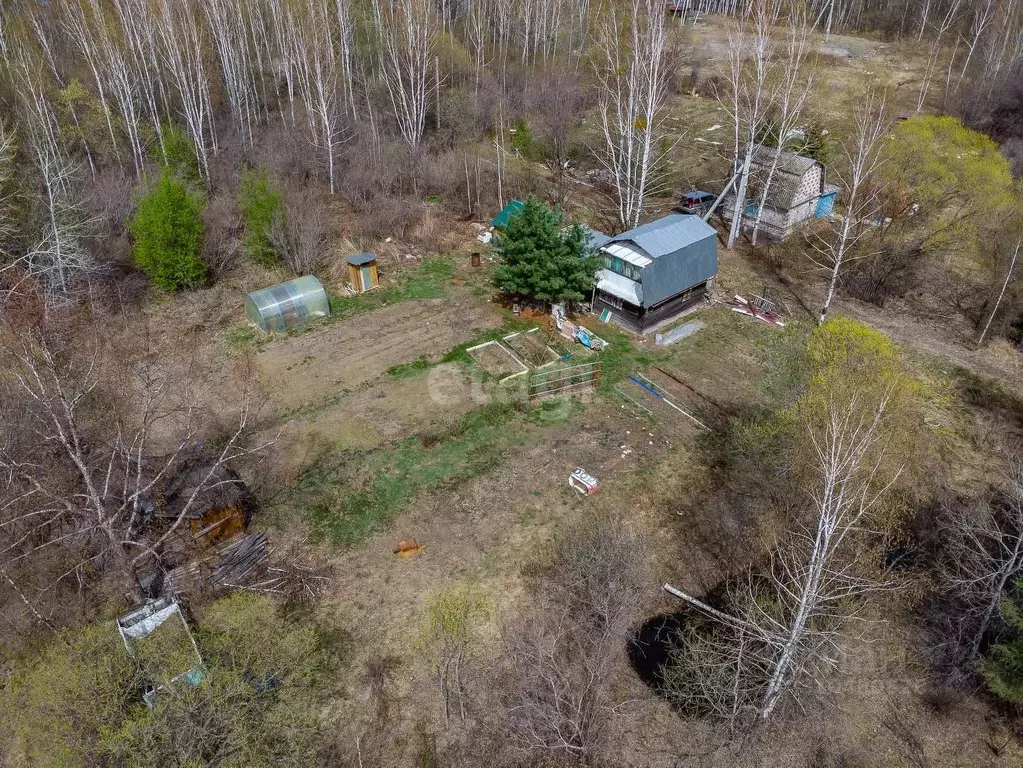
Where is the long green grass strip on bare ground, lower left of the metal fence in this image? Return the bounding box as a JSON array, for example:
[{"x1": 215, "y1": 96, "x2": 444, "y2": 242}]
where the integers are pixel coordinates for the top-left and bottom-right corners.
[{"x1": 292, "y1": 404, "x2": 519, "y2": 546}]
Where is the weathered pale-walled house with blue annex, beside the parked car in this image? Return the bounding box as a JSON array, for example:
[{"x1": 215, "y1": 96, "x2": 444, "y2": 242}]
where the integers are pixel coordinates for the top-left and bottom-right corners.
[{"x1": 721, "y1": 145, "x2": 838, "y2": 240}]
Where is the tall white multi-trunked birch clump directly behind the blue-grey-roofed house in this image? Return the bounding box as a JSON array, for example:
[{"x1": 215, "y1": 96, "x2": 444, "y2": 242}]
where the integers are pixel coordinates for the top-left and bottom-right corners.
[{"x1": 594, "y1": 0, "x2": 670, "y2": 229}]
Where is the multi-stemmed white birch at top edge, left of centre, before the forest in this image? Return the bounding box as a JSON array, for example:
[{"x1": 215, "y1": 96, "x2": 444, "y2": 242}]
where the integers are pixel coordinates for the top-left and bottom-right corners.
[{"x1": 373, "y1": 0, "x2": 437, "y2": 149}]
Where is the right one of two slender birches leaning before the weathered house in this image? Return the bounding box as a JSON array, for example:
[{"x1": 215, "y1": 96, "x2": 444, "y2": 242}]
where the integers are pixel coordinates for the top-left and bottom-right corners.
[{"x1": 750, "y1": 10, "x2": 814, "y2": 245}]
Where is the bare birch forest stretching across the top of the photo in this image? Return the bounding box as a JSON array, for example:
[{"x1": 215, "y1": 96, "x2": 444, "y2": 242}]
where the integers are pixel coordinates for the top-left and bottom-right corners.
[{"x1": 0, "y1": 0, "x2": 1023, "y2": 310}]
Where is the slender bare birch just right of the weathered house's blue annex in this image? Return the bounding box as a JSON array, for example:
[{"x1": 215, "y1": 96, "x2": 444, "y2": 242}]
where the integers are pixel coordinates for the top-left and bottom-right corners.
[{"x1": 811, "y1": 93, "x2": 891, "y2": 323}]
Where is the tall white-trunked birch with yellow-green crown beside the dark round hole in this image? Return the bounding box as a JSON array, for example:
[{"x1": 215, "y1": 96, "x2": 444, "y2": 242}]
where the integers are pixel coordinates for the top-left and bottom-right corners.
[{"x1": 665, "y1": 320, "x2": 917, "y2": 720}]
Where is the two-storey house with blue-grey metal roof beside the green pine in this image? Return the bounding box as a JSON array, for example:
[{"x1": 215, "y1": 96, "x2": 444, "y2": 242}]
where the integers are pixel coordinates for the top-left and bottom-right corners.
[{"x1": 593, "y1": 214, "x2": 717, "y2": 333}]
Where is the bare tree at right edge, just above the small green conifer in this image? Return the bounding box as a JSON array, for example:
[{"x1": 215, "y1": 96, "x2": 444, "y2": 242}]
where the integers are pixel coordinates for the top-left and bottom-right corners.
[{"x1": 940, "y1": 458, "x2": 1023, "y2": 672}]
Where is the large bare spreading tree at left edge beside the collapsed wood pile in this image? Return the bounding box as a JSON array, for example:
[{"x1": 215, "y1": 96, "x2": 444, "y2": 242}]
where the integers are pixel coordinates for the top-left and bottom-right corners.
[{"x1": 0, "y1": 332, "x2": 265, "y2": 617}]
